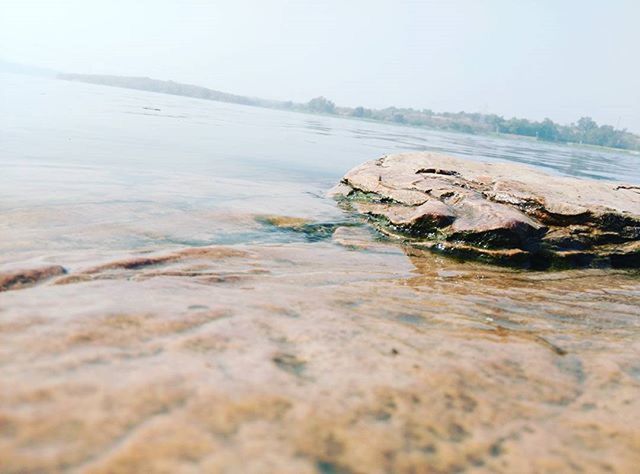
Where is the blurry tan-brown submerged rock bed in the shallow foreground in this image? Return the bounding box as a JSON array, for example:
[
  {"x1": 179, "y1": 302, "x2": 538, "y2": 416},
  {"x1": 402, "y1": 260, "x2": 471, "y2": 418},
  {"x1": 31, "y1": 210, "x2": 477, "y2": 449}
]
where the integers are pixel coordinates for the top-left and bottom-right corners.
[{"x1": 0, "y1": 228, "x2": 640, "y2": 474}]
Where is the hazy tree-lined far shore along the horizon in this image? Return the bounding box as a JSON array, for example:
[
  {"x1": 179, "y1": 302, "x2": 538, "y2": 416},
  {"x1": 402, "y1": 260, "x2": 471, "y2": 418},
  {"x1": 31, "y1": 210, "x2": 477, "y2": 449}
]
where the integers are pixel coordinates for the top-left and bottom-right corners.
[{"x1": 58, "y1": 74, "x2": 640, "y2": 150}]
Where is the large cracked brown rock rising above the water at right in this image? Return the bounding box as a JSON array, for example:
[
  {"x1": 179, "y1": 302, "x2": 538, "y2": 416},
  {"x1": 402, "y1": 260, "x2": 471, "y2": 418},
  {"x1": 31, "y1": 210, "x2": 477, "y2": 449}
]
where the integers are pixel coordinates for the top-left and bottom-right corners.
[{"x1": 332, "y1": 153, "x2": 640, "y2": 268}]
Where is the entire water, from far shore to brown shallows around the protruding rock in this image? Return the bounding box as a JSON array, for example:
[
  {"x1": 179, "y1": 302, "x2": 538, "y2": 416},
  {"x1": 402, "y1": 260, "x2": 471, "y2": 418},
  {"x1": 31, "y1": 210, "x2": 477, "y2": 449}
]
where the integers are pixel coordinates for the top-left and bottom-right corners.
[{"x1": 0, "y1": 75, "x2": 640, "y2": 473}]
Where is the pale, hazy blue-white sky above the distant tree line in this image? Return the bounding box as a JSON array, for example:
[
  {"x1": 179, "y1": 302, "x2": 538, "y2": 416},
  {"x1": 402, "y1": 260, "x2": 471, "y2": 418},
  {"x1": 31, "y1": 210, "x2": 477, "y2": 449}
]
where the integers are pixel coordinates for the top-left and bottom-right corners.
[{"x1": 0, "y1": 0, "x2": 640, "y2": 132}]
